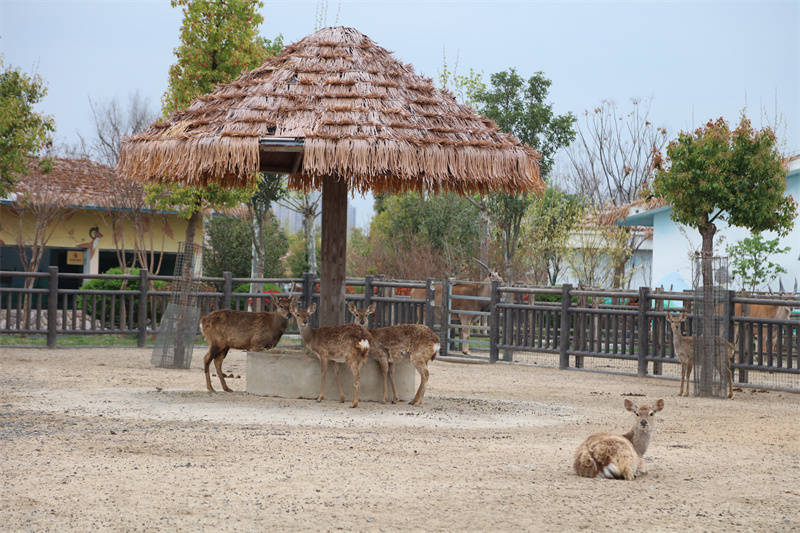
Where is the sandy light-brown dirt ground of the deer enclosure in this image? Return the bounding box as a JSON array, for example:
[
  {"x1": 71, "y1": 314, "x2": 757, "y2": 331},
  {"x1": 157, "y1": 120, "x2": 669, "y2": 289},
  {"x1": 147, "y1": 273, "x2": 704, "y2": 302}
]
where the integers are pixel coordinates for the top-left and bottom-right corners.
[{"x1": 0, "y1": 342, "x2": 800, "y2": 531}]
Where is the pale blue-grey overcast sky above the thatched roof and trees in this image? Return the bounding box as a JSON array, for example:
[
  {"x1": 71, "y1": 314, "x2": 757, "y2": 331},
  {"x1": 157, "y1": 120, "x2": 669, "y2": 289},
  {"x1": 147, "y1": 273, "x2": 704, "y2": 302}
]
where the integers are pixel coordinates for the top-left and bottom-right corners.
[{"x1": 0, "y1": 0, "x2": 800, "y2": 226}]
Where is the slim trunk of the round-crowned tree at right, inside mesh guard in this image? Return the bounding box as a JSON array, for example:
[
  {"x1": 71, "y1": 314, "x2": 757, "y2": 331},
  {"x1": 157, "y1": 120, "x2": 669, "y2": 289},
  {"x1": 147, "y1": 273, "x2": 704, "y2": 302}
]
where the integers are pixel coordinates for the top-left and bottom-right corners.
[{"x1": 695, "y1": 222, "x2": 717, "y2": 396}]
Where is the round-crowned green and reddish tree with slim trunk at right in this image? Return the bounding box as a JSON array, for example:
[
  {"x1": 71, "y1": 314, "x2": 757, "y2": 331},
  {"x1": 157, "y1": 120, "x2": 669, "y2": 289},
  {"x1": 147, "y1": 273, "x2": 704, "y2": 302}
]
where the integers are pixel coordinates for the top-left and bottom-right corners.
[{"x1": 653, "y1": 115, "x2": 796, "y2": 395}]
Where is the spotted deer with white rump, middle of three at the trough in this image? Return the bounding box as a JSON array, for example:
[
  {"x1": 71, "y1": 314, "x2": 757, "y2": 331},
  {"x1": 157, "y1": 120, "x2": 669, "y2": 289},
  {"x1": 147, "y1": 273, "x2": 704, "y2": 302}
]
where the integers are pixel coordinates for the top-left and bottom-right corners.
[{"x1": 291, "y1": 304, "x2": 372, "y2": 407}]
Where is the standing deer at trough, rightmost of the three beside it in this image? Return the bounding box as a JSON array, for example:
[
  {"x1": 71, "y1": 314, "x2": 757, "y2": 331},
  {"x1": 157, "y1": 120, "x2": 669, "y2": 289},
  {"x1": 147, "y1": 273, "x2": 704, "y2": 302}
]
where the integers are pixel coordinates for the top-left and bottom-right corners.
[{"x1": 348, "y1": 302, "x2": 440, "y2": 405}]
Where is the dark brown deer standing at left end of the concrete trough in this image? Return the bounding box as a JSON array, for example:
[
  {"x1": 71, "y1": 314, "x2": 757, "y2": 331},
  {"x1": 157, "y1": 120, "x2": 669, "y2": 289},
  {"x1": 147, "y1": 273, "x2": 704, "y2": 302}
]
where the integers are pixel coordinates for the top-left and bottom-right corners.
[{"x1": 200, "y1": 296, "x2": 297, "y2": 392}]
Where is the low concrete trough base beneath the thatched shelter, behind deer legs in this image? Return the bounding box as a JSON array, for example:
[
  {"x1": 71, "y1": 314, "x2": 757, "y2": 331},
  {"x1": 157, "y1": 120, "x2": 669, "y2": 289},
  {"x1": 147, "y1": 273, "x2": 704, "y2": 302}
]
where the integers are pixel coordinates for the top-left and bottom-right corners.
[{"x1": 247, "y1": 352, "x2": 418, "y2": 402}]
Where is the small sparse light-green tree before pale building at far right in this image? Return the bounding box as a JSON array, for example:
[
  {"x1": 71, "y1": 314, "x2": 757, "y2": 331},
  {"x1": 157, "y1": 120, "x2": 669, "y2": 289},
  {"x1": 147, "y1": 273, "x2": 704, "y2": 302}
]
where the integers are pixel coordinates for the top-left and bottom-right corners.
[{"x1": 726, "y1": 233, "x2": 790, "y2": 292}]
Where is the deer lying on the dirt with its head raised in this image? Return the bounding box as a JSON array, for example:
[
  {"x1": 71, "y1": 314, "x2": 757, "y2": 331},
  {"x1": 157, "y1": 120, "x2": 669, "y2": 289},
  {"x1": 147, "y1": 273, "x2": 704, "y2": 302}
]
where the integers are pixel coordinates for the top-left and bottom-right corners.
[{"x1": 572, "y1": 399, "x2": 664, "y2": 481}]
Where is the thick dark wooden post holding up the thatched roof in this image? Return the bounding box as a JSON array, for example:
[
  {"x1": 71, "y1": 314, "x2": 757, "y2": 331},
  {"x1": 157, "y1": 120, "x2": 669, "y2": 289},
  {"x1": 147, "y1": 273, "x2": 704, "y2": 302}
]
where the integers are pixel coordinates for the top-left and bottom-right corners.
[{"x1": 319, "y1": 176, "x2": 347, "y2": 326}]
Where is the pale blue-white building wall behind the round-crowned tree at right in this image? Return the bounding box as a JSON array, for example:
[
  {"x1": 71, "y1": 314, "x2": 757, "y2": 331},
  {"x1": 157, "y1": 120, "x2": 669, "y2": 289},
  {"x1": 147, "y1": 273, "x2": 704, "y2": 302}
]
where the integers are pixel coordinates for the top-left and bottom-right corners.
[{"x1": 652, "y1": 168, "x2": 800, "y2": 290}]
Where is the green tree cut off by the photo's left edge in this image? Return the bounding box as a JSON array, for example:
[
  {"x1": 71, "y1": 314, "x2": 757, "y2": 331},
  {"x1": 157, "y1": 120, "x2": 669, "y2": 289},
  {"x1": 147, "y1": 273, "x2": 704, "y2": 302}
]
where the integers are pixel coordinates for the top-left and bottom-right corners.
[{"x1": 0, "y1": 56, "x2": 55, "y2": 198}]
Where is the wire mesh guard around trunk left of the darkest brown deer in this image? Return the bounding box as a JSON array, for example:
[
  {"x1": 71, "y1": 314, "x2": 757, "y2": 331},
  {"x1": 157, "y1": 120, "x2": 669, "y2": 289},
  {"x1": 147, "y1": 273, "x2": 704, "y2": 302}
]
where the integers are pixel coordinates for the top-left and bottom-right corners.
[{"x1": 152, "y1": 242, "x2": 203, "y2": 368}]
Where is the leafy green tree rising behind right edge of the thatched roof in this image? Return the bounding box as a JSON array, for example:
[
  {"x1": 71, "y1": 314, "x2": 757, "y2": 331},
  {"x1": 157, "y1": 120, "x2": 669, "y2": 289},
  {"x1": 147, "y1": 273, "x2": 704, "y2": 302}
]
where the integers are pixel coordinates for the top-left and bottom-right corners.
[{"x1": 472, "y1": 68, "x2": 575, "y2": 280}]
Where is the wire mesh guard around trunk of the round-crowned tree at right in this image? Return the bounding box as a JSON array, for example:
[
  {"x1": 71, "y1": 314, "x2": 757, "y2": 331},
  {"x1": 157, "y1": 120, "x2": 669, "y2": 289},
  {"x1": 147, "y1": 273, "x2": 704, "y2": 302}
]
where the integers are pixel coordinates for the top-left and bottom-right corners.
[{"x1": 691, "y1": 254, "x2": 732, "y2": 398}]
